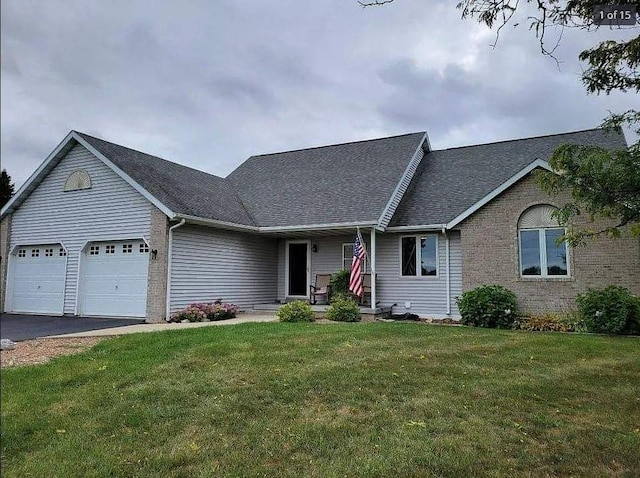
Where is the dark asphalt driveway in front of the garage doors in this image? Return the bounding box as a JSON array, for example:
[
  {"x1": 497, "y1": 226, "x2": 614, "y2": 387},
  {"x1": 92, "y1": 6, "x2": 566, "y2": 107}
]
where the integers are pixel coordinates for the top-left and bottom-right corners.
[{"x1": 0, "y1": 314, "x2": 144, "y2": 342}]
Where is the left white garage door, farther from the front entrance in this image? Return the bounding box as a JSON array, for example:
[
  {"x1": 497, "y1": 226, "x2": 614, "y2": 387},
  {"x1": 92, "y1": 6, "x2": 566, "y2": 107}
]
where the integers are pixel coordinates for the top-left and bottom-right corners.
[{"x1": 7, "y1": 244, "x2": 67, "y2": 315}]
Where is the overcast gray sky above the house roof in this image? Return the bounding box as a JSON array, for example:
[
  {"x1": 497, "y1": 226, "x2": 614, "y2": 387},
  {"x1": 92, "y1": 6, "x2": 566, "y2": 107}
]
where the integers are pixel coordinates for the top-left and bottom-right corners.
[{"x1": 0, "y1": 0, "x2": 640, "y2": 186}]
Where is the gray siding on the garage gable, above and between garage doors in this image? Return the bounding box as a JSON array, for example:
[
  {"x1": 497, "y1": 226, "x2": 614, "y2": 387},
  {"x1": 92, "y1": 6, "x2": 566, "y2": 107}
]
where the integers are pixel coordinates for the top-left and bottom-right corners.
[{"x1": 10, "y1": 145, "x2": 151, "y2": 314}]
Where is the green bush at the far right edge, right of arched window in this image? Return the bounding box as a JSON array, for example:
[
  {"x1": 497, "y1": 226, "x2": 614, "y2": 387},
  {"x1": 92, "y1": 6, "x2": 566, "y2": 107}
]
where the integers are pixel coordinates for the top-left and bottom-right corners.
[{"x1": 576, "y1": 286, "x2": 640, "y2": 334}]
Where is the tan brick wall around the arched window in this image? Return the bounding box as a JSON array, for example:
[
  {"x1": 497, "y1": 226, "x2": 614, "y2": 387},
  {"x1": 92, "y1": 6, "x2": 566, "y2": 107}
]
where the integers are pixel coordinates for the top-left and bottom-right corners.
[{"x1": 460, "y1": 174, "x2": 640, "y2": 313}]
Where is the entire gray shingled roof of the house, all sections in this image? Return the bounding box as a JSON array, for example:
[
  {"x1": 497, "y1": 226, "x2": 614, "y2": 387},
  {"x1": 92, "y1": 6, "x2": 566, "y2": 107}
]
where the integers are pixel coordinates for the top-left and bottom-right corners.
[{"x1": 2, "y1": 129, "x2": 627, "y2": 232}]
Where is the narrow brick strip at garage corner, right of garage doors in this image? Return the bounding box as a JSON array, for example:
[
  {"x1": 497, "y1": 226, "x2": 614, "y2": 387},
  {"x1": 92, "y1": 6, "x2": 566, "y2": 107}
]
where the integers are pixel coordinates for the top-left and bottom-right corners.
[{"x1": 146, "y1": 206, "x2": 169, "y2": 323}]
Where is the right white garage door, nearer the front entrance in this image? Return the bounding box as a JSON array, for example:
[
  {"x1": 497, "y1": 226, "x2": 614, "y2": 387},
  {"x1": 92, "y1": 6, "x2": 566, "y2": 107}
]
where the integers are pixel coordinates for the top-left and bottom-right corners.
[{"x1": 79, "y1": 240, "x2": 149, "y2": 317}]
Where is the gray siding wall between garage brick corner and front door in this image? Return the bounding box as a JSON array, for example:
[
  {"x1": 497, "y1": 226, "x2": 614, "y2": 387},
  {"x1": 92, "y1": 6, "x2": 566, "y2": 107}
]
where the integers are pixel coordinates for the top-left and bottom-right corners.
[{"x1": 170, "y1": 226, "x2": 278, "y2": 312}]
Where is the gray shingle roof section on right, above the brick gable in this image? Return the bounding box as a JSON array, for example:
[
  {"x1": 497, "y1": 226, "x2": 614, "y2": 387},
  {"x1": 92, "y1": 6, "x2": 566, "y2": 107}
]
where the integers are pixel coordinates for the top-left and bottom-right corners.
[{"x1": 390, "y1": 129, "x2": 627, "y2": 226}]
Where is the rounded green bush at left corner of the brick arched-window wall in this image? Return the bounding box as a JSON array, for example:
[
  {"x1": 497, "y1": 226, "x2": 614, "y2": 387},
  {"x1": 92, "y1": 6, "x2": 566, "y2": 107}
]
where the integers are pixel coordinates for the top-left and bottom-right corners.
[{"x1": 456, "y1": 285, "x2": 518, "y2": 329}]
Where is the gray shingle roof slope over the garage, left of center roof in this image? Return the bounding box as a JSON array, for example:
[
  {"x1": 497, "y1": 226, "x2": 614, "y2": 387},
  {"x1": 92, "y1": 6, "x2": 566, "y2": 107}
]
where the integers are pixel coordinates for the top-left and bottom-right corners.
[{"x1": 76, "y1": 132, "x2": 255, "y2": 226}]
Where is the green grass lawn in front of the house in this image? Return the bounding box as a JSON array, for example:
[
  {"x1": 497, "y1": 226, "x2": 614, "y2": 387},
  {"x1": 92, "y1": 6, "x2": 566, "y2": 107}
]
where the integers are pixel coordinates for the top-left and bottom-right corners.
[{"x1": 0, "y1": 324, "x2": 640, "y2": 478}]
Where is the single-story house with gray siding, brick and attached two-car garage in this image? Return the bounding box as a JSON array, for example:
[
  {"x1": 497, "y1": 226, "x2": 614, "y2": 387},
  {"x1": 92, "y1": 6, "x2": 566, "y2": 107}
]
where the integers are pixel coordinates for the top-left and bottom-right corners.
[{"x1": 0, "y1": 129, "x2": 640, "y2": 322}]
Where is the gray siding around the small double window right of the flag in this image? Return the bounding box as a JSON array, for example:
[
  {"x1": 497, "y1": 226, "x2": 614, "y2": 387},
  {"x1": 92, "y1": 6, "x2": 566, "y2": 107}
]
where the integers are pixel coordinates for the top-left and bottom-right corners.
[{"x1": 376, "y1": 232, "x2": 462, "y2": 317}]
